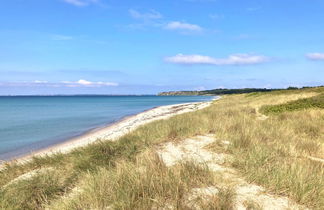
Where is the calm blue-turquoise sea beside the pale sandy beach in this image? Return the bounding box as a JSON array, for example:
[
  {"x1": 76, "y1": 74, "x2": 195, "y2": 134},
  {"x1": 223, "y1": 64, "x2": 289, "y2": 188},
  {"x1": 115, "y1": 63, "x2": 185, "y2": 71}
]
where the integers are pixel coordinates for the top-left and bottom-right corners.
[{"x1": 0, "y1": 96, "x2": 212, "y2": 160}]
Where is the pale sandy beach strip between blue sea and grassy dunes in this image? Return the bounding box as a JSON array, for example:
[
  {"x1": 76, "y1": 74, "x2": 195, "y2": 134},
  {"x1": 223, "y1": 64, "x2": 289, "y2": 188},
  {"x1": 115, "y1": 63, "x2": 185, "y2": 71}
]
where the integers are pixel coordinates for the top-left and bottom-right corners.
[{"x1": 0, "y1": 96, "x2": 220, "y2": 169}]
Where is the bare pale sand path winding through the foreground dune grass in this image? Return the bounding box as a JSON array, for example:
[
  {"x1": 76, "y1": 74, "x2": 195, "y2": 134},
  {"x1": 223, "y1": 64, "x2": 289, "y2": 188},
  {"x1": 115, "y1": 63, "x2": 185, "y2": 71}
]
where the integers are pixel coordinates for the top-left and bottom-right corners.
[{"x1": 157, "y1": 135, "x2": 307, "y2": 210}]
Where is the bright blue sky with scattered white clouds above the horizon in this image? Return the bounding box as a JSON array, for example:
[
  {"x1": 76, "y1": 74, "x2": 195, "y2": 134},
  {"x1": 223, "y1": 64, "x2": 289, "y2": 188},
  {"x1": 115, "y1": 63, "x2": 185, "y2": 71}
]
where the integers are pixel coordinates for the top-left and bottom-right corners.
[{"x1": 0, "y1": 0, "x2": 324, "y2": 95}]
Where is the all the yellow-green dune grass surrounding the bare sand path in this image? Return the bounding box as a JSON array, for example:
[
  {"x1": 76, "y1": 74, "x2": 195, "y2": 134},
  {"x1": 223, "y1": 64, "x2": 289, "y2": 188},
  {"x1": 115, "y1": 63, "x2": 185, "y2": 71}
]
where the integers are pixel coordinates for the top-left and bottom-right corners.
[{"x1": 0, "y1": 88, "x2": 324, "y2": 209}]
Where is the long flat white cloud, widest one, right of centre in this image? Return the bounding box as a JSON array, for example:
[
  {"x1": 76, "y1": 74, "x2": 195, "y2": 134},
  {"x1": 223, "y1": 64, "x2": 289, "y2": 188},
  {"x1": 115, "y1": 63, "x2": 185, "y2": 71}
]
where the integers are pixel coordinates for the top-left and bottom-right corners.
[{"x1": 165, "y1": 54, "x2": 269, "y2": 65}]
